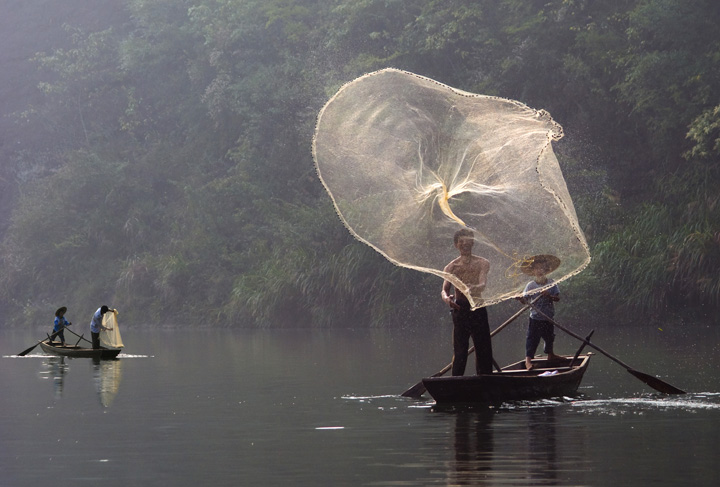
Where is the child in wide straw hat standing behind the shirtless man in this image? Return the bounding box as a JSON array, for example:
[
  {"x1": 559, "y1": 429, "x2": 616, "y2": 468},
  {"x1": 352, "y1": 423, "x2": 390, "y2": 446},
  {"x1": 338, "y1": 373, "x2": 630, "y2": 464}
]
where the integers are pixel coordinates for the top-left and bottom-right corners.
[{"x1": 517, "y1": 254, "x2": 560, "y2": 370}]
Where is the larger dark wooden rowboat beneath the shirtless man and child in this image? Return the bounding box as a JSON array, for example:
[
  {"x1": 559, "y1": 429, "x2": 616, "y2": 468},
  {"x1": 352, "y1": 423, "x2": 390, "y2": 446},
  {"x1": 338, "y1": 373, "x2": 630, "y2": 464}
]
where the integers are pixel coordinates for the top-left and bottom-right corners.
[{"x1": 422, "y1": 353, "x2": 592, "y2": 404}]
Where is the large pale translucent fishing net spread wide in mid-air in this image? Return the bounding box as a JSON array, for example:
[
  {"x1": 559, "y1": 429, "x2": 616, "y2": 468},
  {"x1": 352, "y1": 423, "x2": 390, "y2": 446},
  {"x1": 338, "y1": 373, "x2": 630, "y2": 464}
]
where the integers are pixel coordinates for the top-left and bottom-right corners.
[{"x1": 313, "y1": 69, "x2": 590, "y2": 308}]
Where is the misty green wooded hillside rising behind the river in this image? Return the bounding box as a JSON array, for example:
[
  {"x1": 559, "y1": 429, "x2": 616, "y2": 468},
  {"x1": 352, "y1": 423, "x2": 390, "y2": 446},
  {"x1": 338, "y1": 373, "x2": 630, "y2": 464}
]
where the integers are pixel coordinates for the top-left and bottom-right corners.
[{"x1": 0, "y1": 0, "x2": 720, "y2": 326}]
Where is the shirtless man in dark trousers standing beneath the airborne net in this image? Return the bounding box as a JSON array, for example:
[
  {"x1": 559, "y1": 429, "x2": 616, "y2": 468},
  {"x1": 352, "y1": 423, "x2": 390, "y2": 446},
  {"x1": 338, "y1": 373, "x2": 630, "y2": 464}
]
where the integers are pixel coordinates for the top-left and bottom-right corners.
[{"x1": 440, "y1": 228, "x2": 493, "y2": 376}]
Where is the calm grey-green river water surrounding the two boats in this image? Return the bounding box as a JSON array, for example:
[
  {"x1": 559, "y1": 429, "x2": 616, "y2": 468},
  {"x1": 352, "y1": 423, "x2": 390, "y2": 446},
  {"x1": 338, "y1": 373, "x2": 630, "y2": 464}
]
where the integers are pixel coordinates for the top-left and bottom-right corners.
[{"x1": 0, "y1": 314, "x2": 720, "y2": 487}]
